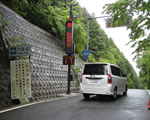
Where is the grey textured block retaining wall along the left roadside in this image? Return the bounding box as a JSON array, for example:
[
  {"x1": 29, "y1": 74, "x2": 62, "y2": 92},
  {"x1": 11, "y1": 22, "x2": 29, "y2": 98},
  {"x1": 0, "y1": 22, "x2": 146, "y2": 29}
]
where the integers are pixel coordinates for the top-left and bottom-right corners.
[{"x1": 0, "y1": 3, "x2": 83, "y2": 106}]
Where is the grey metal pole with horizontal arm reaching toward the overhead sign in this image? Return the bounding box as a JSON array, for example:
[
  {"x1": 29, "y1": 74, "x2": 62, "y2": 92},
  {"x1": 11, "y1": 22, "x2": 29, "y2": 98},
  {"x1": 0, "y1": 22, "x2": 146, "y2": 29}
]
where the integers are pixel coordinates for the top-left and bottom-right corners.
[{"x1": 86, "y1": 16, "x2": 111, "y2": 63}]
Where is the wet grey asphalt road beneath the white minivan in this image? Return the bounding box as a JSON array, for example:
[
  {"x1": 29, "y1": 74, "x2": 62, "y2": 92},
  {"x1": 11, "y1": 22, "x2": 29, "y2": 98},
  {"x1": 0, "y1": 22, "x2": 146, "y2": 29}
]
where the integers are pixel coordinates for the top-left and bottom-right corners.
[{"x1": 0, "y1": 89, "x2": 150, "y2": 120}]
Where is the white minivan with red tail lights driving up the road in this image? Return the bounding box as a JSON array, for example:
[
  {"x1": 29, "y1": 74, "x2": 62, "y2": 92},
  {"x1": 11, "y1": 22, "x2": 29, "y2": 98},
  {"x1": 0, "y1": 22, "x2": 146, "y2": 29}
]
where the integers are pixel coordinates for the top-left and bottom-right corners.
[{"x1": 80, "y1": 63, "x2": 127, "y2": 100}]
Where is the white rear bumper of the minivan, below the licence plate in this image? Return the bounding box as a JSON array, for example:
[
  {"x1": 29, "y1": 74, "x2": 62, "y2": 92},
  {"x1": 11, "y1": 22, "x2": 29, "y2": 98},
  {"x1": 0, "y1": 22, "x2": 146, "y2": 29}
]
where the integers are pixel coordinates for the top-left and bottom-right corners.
[{"x1": 80, "y1": 84, "x2": 113, "y2": 95}]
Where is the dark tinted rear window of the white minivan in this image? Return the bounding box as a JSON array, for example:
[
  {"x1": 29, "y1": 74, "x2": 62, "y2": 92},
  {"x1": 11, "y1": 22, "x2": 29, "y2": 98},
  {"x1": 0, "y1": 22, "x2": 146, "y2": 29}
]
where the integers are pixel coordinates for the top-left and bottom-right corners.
[{"x1": 83, "y1": 64, "x2": 107, "y2": 75}]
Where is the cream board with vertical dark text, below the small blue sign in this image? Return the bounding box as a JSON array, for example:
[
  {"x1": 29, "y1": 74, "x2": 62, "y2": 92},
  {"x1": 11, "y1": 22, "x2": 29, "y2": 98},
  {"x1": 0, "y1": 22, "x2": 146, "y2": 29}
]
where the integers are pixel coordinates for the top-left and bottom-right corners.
[{"x1": 10, "y1": 60, "x2": 31, "y2": 99}]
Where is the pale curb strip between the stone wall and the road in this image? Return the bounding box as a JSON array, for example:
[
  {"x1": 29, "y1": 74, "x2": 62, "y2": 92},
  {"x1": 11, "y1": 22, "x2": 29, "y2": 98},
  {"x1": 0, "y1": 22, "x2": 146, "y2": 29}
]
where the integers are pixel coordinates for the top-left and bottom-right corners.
[{"x1": 0, "y1": 93, "x2": 80, "y2": 114}]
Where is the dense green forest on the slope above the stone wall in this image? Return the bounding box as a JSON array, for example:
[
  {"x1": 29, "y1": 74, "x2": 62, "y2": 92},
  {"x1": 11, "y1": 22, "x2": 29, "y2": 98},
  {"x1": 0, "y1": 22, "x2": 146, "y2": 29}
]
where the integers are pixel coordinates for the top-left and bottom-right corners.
[{"x1": 0, "y1": 0, "x2": 139, "y2": 88}]
